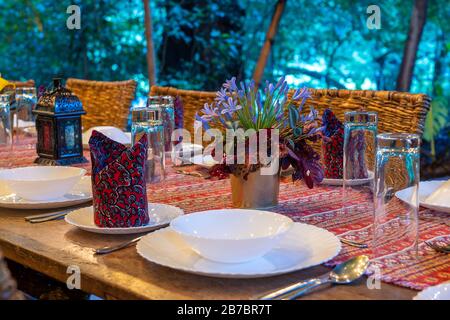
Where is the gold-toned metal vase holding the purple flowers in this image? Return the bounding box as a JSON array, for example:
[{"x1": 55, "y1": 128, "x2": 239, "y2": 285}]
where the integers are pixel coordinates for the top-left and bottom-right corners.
[{"x1": 230, "y1": 170, "x2": 280, "y2": 209}]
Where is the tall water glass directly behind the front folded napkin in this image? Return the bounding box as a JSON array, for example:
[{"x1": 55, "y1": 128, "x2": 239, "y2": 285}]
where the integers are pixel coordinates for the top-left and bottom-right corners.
[{"x1": 131, "y1": 105, "x2": 166, "y2": 183}]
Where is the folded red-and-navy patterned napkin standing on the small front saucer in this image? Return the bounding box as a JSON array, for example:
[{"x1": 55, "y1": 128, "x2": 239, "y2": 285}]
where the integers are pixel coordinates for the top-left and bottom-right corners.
[{"x1": 89, "y1": 130, "x2": 149, "y2": 228}]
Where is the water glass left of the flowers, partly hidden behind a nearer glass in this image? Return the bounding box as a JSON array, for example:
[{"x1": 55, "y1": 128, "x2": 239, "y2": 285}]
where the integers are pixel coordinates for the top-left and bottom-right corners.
[{"x1": 147, "y1": 96, "x2": 175, "y2": 154}]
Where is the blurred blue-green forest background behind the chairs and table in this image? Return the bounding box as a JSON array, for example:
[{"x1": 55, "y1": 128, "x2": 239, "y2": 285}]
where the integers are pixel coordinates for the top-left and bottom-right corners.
[{"x1": 0, "y1": 0, "x2": 450, "y2": 177}]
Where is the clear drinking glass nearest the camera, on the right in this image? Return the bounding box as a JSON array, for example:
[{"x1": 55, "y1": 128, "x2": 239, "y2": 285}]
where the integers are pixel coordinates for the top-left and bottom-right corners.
[{"x1": 373, "y1": 133, "x2": 420, "y2": 257}]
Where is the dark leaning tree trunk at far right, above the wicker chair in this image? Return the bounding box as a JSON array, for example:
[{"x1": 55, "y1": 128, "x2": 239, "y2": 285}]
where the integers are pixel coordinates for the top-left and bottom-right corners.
[{"x1": 397, "y1": 0, "x2": 428, "y2": 91}]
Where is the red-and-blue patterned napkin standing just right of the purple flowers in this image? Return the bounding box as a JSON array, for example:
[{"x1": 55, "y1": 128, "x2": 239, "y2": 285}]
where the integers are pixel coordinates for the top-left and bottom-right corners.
[{"x1": 322, "y1": 109, "x2": 344, "y2": 179}]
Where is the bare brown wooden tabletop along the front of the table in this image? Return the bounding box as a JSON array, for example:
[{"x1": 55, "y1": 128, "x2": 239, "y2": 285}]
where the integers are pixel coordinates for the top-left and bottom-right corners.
[{"x1": 0, "y1": 208, "x2": 416, "y2": 300}]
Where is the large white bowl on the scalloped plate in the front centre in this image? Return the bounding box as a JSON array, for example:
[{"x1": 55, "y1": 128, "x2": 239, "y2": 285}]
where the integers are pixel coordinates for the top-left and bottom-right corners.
[{"x1": 170, "y1": 209, "x2": 294, "y2": 263}]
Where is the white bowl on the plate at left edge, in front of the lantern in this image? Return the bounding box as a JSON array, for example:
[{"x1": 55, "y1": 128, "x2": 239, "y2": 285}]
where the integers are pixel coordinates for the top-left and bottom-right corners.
[{"x1": 0, "y1": 166, "x2": 86, "y2": 201}]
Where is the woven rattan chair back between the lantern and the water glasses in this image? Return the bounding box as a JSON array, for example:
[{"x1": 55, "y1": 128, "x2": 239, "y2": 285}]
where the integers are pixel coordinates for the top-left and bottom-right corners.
[{"x1": 66, "y1": 78, "x2": 136, "y2": 130}]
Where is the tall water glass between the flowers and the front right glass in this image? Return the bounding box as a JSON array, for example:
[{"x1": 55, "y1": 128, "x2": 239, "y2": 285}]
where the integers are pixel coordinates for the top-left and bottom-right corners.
[{"x1": 342, "y1": 111, "x2": 378, "y2": 236}]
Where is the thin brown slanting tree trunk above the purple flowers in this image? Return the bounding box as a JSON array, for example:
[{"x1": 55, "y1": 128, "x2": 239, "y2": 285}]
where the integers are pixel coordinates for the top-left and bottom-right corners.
[{"x1": 253, "y1": 0, "x2": 287, "y2": 87}]
